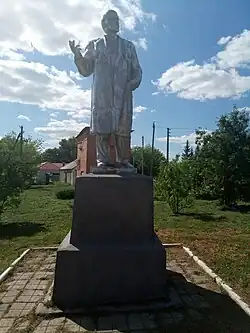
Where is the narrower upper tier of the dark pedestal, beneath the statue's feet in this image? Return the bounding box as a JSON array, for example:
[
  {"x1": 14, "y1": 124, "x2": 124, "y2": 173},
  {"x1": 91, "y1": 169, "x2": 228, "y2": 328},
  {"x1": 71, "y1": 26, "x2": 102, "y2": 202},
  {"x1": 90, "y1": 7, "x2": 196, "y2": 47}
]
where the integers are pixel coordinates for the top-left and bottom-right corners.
[{"x1": 70, "y1": 174, "x2": 153, "y2": 247}]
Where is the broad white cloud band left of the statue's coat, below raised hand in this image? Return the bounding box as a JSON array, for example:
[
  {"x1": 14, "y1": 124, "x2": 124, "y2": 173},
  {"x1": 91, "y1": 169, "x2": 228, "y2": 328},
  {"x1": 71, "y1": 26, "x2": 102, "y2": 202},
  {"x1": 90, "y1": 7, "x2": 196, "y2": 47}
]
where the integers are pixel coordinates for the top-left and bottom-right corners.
[{"x1": 0, "y1": 59, "x2": 90, "y2": 112}]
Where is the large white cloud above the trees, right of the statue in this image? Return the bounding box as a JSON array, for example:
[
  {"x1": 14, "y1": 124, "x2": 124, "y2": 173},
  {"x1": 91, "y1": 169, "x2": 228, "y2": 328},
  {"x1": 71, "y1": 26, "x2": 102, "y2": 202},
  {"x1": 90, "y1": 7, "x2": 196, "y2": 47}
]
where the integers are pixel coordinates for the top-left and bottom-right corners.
[{"x1": 152, "y1": 30, "x2": 250, "y2": 101}]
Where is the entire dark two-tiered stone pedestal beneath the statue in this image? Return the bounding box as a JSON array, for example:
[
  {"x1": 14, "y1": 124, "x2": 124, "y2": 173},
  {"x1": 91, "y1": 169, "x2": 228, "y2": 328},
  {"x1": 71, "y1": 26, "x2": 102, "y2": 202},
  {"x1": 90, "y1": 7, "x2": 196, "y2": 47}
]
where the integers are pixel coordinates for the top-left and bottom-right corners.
[{"x1": 53, "y1": 175, "x2": 166, "y2": 309}]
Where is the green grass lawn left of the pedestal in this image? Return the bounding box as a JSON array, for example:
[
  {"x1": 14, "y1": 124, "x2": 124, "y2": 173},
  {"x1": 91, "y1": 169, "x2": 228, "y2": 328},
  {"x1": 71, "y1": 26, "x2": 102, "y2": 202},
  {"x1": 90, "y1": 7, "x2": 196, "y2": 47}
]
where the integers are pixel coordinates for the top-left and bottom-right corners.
[{"x1": 0, "y1": 185, "x2": 72, "y2": 272}]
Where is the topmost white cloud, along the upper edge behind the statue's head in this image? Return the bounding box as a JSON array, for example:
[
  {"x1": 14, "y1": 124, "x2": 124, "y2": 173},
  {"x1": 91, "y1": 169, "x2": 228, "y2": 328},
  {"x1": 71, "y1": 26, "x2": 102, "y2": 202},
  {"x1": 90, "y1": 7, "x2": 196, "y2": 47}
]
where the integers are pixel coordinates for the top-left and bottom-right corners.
[{"x1": 0, "y1": 0, "x2": 155, "y2": 55}]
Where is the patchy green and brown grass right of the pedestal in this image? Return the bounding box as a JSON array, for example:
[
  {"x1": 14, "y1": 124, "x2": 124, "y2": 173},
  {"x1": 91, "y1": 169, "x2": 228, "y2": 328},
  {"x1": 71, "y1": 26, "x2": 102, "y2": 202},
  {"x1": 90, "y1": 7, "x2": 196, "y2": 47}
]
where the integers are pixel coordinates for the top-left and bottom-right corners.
[{"x1": 155, "y1": 200, "x2": 250, "y2": 302}]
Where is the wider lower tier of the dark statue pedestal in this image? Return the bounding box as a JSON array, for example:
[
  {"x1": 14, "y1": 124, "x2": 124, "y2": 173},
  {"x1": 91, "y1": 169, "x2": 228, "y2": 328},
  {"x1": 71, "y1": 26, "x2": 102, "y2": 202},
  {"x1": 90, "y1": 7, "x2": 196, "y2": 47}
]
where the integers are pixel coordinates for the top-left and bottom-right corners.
[{"x1": 53, "y1": 234, "x2": 166, "y2": 309}]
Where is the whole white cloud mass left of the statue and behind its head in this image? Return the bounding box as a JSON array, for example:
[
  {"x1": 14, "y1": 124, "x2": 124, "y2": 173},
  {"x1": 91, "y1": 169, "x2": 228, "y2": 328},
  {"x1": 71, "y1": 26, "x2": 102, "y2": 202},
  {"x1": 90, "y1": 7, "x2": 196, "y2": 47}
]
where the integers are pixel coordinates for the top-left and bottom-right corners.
[{"x1": 0, "y1": 0, "x2": 156, "y2": 143}]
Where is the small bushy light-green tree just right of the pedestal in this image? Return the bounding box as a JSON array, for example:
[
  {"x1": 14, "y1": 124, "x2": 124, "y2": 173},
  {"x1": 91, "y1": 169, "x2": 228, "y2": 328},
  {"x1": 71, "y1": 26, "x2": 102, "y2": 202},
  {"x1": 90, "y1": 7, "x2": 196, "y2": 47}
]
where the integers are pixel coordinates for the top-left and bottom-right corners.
[{"x1": 155, "y1": 159, "x2": 193, "y2": 214}]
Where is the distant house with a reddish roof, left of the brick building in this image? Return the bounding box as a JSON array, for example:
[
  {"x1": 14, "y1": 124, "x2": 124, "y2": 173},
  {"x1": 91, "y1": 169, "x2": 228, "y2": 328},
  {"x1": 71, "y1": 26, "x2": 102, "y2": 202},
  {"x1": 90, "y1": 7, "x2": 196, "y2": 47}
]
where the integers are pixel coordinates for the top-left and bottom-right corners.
[{"x1": 36, "y1": 162, "x2": 64, "y2": 184}]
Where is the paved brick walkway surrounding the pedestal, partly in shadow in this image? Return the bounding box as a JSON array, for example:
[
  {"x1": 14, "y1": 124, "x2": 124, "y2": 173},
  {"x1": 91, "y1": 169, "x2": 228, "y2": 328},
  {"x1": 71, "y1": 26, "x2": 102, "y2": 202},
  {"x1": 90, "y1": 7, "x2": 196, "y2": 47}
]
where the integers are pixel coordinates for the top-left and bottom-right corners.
[{"x1": 0, "y1": 249, "x2": 250, "y2": 333}]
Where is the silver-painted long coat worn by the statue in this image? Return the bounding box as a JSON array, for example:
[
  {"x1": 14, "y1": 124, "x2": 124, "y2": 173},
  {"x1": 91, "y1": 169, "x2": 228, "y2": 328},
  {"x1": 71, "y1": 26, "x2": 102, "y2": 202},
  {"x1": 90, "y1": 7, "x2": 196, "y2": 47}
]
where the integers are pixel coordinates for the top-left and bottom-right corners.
[{"x1": 75, "y1": 36, "x2": 142, "y2": 137}]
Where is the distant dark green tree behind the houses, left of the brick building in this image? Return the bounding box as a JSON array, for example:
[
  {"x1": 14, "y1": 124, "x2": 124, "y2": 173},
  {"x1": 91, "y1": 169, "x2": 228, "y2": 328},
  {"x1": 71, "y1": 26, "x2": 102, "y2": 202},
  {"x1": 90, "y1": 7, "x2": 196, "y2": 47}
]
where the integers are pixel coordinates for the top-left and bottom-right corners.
[{"x1": 42, "y1": 137, "x2": 76, "y2": 163}]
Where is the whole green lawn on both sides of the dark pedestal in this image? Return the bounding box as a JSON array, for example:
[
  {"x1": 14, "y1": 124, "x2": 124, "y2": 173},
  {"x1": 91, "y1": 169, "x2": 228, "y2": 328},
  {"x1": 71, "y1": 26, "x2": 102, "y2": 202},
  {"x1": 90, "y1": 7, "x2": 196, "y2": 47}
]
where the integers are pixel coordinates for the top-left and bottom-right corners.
[{"x1": 0, "y1": 185, "x2": 250, "y2": 302}]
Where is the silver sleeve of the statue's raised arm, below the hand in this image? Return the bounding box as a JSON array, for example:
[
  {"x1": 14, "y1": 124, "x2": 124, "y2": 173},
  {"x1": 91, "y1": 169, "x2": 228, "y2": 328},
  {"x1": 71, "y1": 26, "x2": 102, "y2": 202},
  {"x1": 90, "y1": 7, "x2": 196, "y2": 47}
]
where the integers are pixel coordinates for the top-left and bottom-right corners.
[{"x1": 75, "y1": 42, "x2": 95, "y2": 77}]
